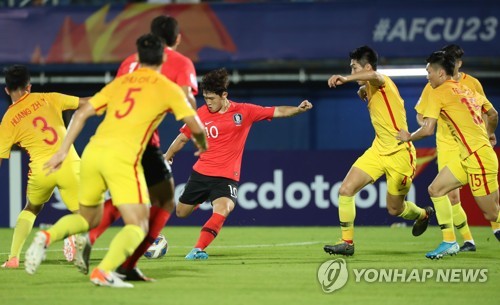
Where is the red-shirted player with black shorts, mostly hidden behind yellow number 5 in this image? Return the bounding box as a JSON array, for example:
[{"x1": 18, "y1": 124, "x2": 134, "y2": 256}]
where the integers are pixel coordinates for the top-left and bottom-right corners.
[{"x1": 79, "y1": 15, "x2": 198, "y2": 281}]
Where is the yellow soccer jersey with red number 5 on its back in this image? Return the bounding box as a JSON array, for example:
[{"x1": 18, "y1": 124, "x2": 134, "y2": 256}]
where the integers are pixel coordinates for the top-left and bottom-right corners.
[{"x1": 89, "y1": 68, "x2": 196, "y2": 160}]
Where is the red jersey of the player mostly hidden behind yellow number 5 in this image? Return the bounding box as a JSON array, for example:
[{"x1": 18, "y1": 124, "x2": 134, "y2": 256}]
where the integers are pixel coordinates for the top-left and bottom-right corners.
[{"x1": 116, "y1": 48, "x2": 198, "y2": 147}]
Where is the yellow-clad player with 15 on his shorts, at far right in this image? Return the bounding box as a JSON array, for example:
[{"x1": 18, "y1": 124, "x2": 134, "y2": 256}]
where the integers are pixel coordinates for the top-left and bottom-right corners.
[{"x1": 397, "y1": 51, "x2": 500, "y2": 259}]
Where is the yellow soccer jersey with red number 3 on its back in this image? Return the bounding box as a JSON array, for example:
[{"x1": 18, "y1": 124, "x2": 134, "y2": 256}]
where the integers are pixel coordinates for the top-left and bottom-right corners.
[{"x1": 0, "y1": 93, "x2": 79, "y2": 163}]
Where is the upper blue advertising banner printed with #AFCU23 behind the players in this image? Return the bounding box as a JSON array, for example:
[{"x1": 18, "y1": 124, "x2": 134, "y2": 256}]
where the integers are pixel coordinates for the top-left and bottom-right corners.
[{"x1": 0, "y1": 0, "x2": 500, "y2": 64}]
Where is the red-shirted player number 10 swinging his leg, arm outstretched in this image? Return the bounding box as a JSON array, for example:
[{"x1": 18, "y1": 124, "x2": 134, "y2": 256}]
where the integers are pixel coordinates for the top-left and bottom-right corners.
[{"x1": 165, "y1": 69, "x2": 312, "y2": 260}]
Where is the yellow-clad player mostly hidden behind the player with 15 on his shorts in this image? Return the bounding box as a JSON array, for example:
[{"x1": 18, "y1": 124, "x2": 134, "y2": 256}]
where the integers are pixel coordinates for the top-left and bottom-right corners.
[{"x1": 415, "y1": 44, "x2": 500, "y2": 252}]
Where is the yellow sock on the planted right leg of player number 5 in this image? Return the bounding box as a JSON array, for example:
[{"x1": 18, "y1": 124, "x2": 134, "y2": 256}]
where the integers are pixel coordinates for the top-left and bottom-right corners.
[{"x1": 97, "y1": 225, "x2": 146, "y2": 272}]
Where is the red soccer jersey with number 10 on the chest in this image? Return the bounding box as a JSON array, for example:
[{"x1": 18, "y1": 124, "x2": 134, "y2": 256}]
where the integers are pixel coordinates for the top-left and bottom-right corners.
[{"x1": 181, "y1": 101, "x2": 274, "y2": 181}]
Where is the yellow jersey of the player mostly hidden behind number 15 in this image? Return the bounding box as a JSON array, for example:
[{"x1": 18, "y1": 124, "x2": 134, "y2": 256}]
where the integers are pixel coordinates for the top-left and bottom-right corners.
[{"x1": 415, "y1": 72, "x2": 492, "y2": 150}]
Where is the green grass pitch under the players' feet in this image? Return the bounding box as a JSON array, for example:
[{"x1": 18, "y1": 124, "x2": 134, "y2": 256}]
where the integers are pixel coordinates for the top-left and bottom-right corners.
[{"x1": 0, "y1": 226, "x2": 500, "y2": 305}]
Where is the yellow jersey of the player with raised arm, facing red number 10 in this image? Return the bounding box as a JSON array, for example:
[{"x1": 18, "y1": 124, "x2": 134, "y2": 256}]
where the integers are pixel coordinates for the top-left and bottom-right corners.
[{"x1": 366, "y1": 75, "x2": 408, "y2": 155}]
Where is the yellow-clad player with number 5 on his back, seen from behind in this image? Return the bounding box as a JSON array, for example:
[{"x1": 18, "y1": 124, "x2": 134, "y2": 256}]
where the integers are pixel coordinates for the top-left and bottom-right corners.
[{"x1": 25, "y1": 34, "x2": 207, "y2": 288}]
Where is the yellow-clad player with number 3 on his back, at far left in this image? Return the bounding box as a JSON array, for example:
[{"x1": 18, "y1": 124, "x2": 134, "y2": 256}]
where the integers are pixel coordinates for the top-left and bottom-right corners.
[{"x1": 0, "y1": 65, "x2": 86, "y2": 268}]
